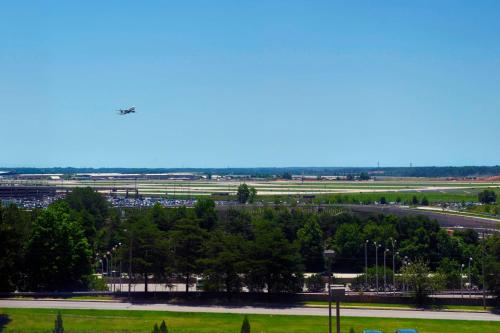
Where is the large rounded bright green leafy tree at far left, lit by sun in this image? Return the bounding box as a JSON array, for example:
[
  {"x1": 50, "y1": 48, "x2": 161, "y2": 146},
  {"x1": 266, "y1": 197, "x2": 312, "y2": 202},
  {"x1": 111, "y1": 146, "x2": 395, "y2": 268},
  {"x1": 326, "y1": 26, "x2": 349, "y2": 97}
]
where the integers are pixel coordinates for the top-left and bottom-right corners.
[{"x1": 26, "y1": 201, "x2": 92, "y2": 290}]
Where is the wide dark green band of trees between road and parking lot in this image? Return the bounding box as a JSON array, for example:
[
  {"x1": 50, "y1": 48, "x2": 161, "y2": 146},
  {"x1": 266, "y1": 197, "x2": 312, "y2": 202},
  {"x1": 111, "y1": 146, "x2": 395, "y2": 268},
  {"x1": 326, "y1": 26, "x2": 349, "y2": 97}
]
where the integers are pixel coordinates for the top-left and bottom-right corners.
[{"x1": 0, "y1": 189, "x2": 500, "y2": 295}]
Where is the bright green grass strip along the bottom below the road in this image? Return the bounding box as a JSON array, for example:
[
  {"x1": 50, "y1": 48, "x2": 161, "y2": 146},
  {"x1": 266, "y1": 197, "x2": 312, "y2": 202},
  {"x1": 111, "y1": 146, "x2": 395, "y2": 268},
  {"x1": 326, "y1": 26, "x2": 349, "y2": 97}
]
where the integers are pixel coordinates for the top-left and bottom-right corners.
[{"x1": 0, "y1": 309, "x2": 500, "y2": 333}]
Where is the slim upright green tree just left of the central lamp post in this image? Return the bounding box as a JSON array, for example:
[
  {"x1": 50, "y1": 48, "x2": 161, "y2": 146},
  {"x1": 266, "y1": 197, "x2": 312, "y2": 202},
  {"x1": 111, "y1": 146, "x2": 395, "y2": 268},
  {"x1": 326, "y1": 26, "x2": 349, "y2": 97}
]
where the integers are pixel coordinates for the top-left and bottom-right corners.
[{"x1": 297, "y1": 217, "x2": 325, "y2": 272}]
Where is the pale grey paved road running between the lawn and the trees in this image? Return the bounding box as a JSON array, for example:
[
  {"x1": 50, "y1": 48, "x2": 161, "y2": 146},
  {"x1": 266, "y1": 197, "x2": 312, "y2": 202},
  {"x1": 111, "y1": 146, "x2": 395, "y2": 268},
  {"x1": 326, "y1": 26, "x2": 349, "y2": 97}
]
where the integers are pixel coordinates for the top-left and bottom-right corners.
[{"x1": 0, "y1": 299, "x2": 500, "y2": 322}]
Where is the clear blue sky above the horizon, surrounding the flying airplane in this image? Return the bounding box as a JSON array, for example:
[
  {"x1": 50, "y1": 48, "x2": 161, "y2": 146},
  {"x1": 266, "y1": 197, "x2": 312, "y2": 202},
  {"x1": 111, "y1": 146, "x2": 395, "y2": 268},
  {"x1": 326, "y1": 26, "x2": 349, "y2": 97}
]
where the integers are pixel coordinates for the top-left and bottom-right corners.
[{"x1": 0, "y1": 0, "x2": 500, "y2": 167}]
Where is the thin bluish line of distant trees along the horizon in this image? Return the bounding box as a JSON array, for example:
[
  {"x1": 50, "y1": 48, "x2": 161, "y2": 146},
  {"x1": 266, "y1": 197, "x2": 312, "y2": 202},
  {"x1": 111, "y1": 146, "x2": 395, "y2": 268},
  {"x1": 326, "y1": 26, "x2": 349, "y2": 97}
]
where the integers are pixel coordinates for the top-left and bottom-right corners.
[{"x1": 0, "y1": 165, "x2": 500, "y2": 178}]
